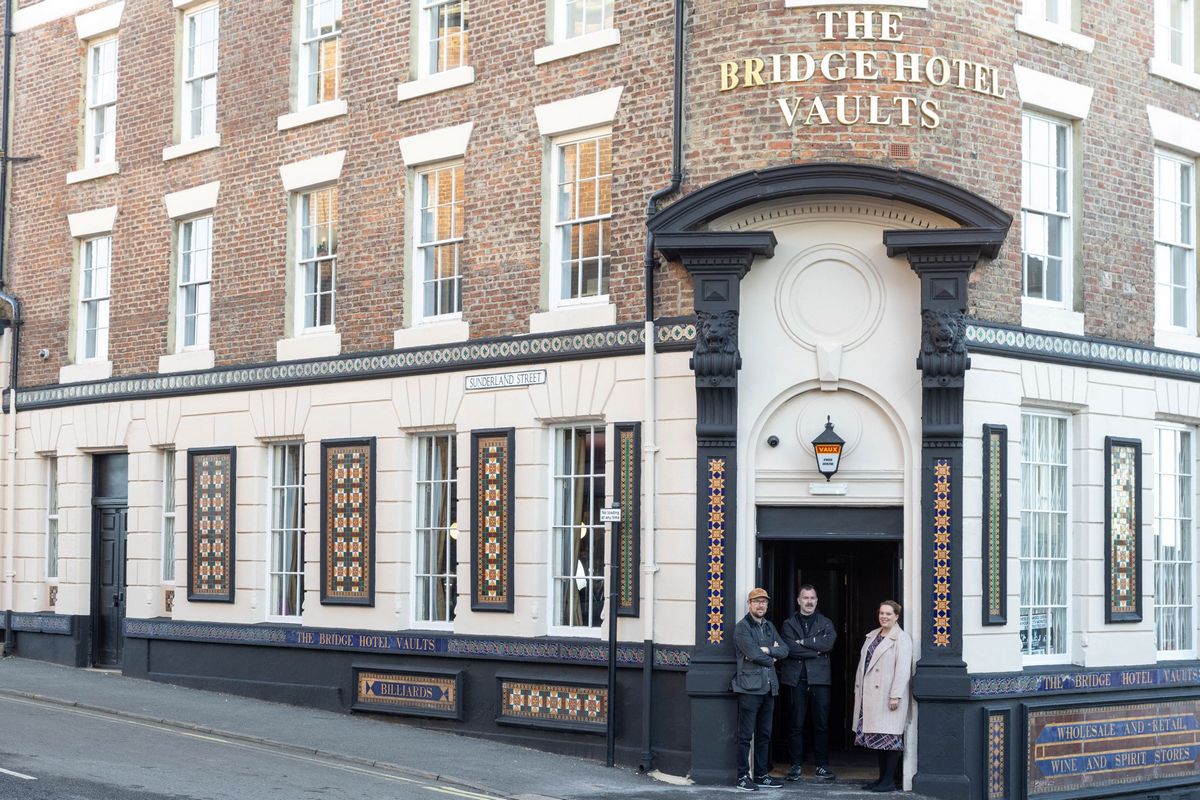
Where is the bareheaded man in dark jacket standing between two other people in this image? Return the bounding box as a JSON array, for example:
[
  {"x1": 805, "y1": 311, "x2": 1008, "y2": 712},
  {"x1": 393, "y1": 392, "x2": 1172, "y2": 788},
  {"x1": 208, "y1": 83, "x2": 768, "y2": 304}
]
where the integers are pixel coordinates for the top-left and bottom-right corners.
[{"x1": 781, "y1": 584, "x2": 838, "y2": 781}]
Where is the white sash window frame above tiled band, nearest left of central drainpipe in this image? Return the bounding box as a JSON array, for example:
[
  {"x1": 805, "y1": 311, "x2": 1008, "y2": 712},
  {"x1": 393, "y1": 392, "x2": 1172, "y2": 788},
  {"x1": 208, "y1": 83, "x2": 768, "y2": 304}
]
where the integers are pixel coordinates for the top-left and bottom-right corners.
[{"x1": 550, "y1": 126, "x2": 613, "y2": 308}]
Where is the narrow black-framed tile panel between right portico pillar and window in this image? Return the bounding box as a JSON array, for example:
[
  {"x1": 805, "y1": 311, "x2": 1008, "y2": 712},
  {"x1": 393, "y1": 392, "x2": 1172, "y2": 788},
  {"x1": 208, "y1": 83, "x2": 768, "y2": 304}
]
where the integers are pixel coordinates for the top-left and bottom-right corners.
[{"x1": 983, "y1": 425, "x2": 1008, "y2": 625}]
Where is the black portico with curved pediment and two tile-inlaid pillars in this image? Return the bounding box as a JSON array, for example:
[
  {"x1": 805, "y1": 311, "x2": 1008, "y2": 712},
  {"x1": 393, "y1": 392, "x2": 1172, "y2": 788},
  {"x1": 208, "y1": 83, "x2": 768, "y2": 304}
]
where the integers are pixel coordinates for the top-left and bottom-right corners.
[{"x1": 650, "y1": 163, "x2": 1012, "y2": 799}]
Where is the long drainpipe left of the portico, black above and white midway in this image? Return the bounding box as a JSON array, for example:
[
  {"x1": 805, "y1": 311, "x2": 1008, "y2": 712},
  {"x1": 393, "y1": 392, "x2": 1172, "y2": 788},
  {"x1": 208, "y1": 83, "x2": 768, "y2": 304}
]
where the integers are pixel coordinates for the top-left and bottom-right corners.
[{"x1": 638, "y1": 0, "x2": 684, "y2": 772}]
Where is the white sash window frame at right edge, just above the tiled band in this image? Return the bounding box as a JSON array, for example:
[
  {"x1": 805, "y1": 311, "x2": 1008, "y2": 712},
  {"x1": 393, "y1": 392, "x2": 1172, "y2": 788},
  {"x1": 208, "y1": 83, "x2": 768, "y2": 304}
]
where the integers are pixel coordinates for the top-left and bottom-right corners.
[{"x1": 1153, "y1": 149, "x2": 1198, "y2": 336}]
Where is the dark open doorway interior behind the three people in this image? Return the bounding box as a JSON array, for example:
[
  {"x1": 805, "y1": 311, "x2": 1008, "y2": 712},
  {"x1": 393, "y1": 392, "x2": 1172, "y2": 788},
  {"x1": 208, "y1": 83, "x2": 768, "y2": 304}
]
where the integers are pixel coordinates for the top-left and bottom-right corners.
[{"x1": 760, "y1": 539, "x2": 902, "y2": 777}]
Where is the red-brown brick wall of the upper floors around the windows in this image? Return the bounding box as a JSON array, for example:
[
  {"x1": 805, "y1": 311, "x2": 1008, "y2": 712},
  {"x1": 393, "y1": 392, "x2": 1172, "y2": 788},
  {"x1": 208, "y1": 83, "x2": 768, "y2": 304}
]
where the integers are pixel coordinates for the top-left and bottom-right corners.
[{"x1": 4, "y1": 0, "x2": 1200, "y2": 385}]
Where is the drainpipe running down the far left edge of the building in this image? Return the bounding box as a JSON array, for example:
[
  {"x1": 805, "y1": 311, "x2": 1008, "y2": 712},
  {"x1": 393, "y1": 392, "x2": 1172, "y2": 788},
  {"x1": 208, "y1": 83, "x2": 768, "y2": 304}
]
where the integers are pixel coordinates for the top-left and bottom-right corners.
[{"x1": 0, "y1": 0, "x2": 20, "y2": 656}]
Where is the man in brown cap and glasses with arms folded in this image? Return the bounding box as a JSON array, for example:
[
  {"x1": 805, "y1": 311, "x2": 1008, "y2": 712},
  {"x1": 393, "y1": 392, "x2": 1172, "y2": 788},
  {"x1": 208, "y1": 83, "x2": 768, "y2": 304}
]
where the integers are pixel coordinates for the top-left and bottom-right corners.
[{"x1": 731, "y1": 588, "x2": 788, "y2": 792}]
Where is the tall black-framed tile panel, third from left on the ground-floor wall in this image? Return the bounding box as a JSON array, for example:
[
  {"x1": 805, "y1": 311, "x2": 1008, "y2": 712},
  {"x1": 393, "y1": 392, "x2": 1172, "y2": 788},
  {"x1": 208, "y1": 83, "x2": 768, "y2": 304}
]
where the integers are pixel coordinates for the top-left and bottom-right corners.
[{"x1": 470, "y1": 428, "x2": 516, "y2": 612}]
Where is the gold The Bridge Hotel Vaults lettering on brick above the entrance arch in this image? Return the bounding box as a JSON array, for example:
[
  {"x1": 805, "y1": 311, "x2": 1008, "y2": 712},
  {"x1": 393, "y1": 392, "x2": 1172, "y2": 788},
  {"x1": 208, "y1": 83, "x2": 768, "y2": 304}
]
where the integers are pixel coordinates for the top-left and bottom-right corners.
[{"x1": 716, "y1": 11, "x2": 1007, "y2": 128}]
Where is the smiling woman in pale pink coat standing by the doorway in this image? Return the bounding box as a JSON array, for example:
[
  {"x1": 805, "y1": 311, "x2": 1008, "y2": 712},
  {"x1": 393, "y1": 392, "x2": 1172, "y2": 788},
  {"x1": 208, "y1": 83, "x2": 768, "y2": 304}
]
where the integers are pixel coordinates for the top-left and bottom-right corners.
[{"x1": 851, "y1": 600, "x2": 912, "y2": 792}]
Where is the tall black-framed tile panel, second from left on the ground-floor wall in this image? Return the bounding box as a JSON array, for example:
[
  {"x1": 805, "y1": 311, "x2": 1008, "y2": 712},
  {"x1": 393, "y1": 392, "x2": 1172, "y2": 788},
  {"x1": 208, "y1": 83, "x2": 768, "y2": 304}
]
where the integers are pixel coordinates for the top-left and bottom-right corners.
[{"x1": 320, "y1": 437, "x2": 376, "y2": 606}]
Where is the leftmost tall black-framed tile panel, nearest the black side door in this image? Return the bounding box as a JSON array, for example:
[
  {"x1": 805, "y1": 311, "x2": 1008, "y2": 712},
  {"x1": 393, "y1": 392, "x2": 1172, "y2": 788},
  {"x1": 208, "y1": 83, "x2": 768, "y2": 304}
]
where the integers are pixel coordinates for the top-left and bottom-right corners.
[{"x1": 187, "y1": 447, "x2": 238, "y2": 603}]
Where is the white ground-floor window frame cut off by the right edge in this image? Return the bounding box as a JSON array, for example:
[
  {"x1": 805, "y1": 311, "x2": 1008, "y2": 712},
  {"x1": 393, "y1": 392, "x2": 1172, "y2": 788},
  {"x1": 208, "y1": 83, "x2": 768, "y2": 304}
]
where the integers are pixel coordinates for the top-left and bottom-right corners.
[{"x1": 1152, "y1": 423, "x2": 1198, "y2": 661}]
